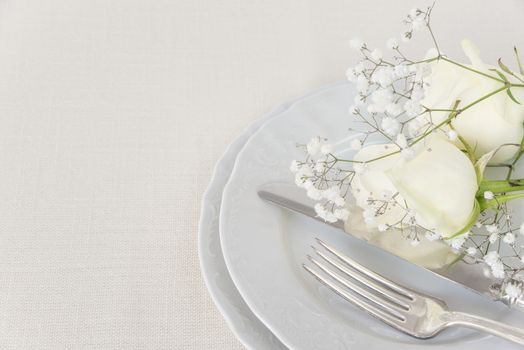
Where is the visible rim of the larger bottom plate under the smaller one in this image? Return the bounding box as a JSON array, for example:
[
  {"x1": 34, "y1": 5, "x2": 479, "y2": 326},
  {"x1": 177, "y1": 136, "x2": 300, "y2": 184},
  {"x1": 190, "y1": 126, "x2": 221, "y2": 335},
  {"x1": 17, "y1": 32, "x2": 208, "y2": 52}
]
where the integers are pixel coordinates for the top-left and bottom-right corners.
[{"x1": 198, "y1": 97, "x2": 298, "y2": 349}]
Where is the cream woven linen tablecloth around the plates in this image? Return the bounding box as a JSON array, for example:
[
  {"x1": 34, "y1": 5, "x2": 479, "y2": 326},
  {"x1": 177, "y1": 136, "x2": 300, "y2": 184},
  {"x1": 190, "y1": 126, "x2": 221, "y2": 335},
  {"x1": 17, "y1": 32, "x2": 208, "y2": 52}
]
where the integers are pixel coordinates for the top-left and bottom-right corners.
[{"x1": 0, "y1": 0, "x2": 524, "y2": 349}]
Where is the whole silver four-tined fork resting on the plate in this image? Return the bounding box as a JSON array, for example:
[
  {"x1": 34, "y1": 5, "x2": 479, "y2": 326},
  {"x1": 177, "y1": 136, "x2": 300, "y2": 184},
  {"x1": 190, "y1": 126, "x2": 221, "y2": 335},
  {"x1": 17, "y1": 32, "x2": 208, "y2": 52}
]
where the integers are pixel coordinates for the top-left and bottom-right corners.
[{"x1": 302, "y1": 239, "x2": 524, "y2": 345}]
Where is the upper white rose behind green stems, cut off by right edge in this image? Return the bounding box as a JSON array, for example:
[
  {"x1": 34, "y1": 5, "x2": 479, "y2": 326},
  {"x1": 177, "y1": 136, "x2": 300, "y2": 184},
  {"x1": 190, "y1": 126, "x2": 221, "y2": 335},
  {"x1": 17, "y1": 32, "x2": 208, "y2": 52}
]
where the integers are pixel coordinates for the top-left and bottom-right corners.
[{"x1": 421, "y1": 40, "x2": 524, "y2": 164}]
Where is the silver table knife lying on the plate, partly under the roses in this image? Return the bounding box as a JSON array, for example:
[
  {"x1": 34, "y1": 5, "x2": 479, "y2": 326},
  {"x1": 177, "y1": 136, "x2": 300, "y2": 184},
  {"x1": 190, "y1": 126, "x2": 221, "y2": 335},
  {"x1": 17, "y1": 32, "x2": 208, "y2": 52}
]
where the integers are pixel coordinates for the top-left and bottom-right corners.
[{"x1": 258, "y1": 183, "x2": 524, "y2": 311}]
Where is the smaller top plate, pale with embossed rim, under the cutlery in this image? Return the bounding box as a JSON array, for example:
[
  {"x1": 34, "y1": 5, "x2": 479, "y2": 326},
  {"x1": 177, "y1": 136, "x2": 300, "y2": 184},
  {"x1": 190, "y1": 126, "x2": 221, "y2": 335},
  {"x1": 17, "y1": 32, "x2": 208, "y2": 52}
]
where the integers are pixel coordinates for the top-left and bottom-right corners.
[{"x1": 220, "y1": 84, "x2": 524, "y2": 350}]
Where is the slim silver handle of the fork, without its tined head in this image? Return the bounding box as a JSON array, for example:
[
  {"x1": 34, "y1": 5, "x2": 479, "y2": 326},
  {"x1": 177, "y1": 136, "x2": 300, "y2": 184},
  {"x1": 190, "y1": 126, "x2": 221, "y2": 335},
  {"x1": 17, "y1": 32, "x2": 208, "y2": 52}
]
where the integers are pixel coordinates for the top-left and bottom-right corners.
[{"x1": 443, "y1": 312, "x2": 524, "y2": 345}]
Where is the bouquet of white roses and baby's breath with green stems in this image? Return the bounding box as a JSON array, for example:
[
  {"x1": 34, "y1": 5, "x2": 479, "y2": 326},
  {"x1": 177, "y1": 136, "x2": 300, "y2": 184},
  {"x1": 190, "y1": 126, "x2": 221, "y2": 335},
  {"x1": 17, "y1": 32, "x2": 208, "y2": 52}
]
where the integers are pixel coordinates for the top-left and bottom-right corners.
[{"x1": 291, "y1": 6, "x2": 524, "y2": 298}]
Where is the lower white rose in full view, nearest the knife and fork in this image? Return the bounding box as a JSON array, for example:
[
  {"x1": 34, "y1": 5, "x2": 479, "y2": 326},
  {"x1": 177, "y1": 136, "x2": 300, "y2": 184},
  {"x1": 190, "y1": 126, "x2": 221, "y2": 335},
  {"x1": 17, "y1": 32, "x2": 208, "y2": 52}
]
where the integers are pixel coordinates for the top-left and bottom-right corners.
[{"x1": 352, "y1": 135, "x2": 478, "y2": 237}]
